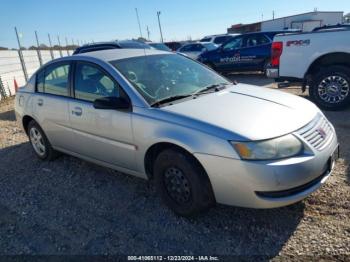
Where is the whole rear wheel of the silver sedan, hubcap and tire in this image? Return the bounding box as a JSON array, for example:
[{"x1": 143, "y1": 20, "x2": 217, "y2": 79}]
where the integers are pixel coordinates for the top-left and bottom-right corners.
[{"x1": 27, "y1": 120, "x2": 59, "y2": 161}]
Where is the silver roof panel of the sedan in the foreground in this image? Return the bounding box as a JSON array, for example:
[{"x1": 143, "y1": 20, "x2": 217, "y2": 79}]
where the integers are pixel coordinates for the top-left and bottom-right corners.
[{"x1": 75, "y1": 48, "x2": 173, "y2": 62}]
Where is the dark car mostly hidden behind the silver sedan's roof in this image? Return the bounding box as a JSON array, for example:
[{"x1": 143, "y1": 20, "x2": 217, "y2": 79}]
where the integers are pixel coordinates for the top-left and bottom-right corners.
[{"x1": 73, "y1": 40, "x2": 152, "y2": 55}]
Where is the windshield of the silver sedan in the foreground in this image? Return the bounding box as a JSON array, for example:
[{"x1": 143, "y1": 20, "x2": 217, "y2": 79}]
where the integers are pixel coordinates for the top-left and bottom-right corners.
[{"x1": 110, "y1": 54, "x2": 230, "y2": 105}]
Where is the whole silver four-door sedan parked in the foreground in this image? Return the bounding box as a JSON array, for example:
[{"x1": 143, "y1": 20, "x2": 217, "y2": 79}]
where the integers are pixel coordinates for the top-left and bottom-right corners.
[{"x1": 16, "y1": 49, "x2": 338, "y2": 216}]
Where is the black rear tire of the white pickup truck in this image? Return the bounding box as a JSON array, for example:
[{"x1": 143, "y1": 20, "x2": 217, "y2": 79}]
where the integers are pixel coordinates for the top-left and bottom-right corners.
[{"x1": 309, "y1": 65, "x2": 350, "y2": 110}]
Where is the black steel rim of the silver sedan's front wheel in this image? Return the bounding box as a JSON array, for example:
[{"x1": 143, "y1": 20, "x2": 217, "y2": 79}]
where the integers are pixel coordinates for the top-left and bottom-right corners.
[{"x1": 164, "y1": 167, "x2": 191, "y2": 204}]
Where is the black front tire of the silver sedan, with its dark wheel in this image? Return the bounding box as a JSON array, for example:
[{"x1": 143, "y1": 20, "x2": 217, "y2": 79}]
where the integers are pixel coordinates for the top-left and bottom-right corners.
[{"x1": 153, "y1": 149, "x2": 215, "y2": 217}]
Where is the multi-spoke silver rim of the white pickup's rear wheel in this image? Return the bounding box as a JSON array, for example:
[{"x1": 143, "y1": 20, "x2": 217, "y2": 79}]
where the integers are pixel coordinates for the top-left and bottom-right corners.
[{"x1": 318, "y1": 76, "x2": 350, "y2": 104}]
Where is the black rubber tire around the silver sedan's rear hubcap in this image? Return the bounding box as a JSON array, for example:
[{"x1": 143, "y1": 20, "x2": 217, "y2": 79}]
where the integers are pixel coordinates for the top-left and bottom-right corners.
[{"x1": 27, "y1": 120, "x2": 59, "y2": 161}]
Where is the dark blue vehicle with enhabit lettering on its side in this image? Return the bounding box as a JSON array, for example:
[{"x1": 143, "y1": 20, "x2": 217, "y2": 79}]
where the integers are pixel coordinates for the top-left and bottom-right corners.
[{"x1": 198, "y1": 31, "x2": 296, "y2": 72}]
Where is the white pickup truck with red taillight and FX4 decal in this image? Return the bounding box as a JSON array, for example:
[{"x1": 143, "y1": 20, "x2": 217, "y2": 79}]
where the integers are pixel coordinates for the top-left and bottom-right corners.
[{"x1": 266, "y1": 25, "x2": 350, "y2": 110}]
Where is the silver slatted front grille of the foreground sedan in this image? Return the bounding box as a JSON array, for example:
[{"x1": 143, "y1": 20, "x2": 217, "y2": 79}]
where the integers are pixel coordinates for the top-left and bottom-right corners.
[{"x1": 297, "y1": 114, "x2": 333, "y2": 151}]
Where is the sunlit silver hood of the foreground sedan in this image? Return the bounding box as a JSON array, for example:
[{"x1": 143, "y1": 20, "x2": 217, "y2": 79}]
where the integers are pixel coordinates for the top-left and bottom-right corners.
[{"x1": 162, "y1": 84, "x2": 319, "y2": 140}]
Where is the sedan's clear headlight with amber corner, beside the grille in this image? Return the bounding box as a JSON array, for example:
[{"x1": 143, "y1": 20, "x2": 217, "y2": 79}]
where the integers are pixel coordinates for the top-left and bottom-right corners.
[{"x1": 230, "y1": 135, "x2": 303, "y2": 160}]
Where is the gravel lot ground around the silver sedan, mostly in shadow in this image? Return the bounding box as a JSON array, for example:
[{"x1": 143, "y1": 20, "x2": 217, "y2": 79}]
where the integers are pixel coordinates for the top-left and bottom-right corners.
[{"x1": 0, "y1": 75, "x2": 350, "y2": 260}]
